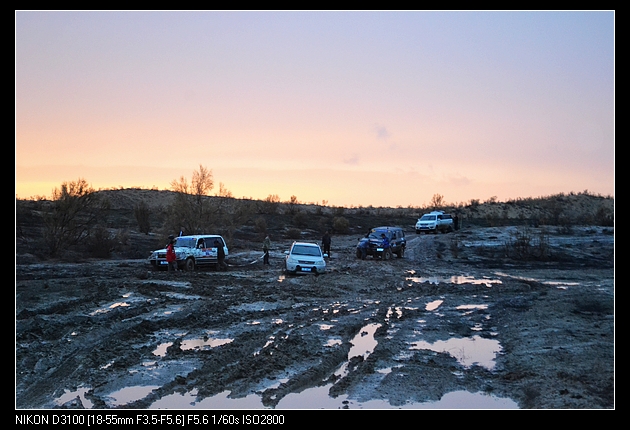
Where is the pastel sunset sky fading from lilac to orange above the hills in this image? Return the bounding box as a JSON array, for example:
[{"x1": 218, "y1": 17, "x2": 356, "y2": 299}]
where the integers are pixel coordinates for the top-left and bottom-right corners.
[{"x1": 15, "y1": 11, "x2": 615, "y2": 207}]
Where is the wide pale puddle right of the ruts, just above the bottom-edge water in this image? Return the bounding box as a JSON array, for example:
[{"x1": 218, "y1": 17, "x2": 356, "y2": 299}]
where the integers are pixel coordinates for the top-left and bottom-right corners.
[{"x1": 410, "y1": 336, "x2": 501, "y2": 370}]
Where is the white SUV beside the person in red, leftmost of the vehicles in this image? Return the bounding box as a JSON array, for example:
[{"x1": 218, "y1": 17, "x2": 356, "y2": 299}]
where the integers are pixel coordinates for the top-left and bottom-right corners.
[{"x1": 149, "y1": 234, "x2": 228, "y2": 270}]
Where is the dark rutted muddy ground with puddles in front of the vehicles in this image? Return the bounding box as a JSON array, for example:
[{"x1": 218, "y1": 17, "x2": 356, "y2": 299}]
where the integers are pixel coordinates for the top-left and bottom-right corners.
[{"x1": 15, "y1": 227, "x2": 615, "y2": 409}]
